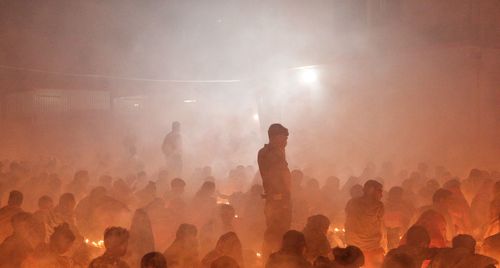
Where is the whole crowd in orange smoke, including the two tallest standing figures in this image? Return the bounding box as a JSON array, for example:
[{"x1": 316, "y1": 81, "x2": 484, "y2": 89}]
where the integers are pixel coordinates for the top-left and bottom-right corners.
[{"x1": 0, "y1": 123, "x2": 500, "y2": 268}]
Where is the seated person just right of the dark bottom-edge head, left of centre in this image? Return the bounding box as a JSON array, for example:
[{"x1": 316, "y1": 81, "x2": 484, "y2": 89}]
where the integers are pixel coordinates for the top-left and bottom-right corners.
[{"x1": 163, "y1": 223, "x2": 200, "y2": 268}]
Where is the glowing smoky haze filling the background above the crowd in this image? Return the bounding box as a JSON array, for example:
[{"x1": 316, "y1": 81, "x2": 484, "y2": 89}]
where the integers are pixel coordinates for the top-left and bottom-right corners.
[{"x1": 0, "y1": 0, "x2": 500, "y2": 179}]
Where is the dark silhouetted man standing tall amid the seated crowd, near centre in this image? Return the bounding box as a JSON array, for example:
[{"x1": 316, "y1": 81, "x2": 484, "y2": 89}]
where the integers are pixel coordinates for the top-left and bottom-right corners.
[{"x1": 257, "y1": 124, "x2": 292, "y2": 257}]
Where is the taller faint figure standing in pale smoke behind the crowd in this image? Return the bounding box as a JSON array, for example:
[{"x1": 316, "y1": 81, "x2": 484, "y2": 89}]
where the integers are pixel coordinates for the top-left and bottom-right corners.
[{"x1": 161, "y1": 121, "x2": 182, "y2": 176}]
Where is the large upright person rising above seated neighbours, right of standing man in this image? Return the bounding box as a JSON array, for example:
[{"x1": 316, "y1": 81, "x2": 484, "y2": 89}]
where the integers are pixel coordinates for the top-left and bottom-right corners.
[{"x1": 345, "y1": 180, "x2": 384, "y2": 267}]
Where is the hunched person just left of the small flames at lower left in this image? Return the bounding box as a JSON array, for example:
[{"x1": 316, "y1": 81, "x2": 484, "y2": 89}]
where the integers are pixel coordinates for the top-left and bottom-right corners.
[{"x1": 21, "y1": 223, "x2": 75, "y2": 268}]
